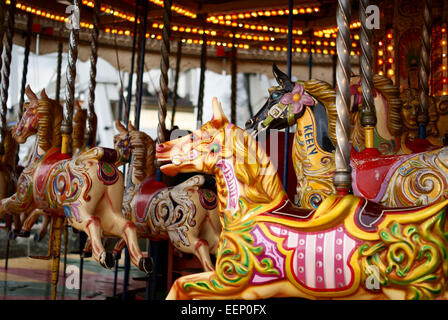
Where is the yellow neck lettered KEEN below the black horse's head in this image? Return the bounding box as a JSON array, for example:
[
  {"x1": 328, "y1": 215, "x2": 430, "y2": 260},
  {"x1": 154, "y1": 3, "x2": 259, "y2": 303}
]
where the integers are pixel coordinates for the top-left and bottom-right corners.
[{"x1": 293, "y1": 107, "x2": 334, "y2": 174}]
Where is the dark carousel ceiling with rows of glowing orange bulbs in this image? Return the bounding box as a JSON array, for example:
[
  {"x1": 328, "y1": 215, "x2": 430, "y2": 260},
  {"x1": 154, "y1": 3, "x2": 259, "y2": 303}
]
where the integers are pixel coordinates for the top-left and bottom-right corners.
[{"x1": 6, "y1": 0, "x2": 441, "y2": 73}]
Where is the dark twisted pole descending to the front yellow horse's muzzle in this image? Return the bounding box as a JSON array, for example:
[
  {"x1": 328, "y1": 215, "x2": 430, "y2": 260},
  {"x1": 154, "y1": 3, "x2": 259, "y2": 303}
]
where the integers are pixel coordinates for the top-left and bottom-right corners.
[{"x1": 157, "y1": 0, "x2": 172, "y2": 143}]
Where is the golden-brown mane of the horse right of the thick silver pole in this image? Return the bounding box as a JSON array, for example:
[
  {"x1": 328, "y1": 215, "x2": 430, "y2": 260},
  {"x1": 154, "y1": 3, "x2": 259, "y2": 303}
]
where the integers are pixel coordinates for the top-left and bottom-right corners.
[{"x1": 373, "y1": 74, "x2": 403, "y2": 137}]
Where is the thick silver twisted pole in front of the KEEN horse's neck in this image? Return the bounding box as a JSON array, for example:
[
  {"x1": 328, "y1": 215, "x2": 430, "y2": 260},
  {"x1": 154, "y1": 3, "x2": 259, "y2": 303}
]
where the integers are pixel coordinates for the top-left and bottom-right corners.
[{"x1": 333, "y1": 0, "x2": 352, "y2": 194}]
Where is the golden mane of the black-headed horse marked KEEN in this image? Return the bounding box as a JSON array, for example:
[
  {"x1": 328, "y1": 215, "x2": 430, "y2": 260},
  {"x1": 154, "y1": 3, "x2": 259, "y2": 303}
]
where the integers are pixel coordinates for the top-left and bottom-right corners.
[{"x1": 303, "y1": 79, "x2": 338, "y2": 146}]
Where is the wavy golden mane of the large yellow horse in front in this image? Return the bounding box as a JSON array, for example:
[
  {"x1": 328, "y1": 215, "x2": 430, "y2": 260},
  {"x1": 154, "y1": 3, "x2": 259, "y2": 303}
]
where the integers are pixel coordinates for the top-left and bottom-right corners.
[{"x1": 226, "y1": 128, "x2": 283, "y2": 204}]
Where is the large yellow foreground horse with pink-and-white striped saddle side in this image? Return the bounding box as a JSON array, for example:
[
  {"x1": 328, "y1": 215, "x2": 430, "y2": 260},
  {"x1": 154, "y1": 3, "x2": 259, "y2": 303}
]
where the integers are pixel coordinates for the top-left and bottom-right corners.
[{"x1": 156, "y1": 99, "x2": 448, "y2": 299}]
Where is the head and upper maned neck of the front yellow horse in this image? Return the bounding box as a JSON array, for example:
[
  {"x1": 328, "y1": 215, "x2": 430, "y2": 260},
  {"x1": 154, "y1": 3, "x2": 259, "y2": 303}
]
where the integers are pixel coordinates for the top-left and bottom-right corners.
[{"x1": 156, "y1": 98, "x2": 286, "y2": 212}]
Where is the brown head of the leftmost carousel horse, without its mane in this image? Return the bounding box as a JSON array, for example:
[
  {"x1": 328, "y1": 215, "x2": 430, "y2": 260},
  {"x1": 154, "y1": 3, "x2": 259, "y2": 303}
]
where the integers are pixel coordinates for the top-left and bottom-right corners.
[{"x1": 12, "y1": 85, "x2": 39, "y2": 143}]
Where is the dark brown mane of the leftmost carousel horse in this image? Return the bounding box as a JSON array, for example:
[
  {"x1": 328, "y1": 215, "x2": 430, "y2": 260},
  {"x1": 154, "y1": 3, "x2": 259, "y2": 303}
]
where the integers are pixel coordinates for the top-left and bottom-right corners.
[{"x1": 37, "y1": 98, "x2": 63, "y2": 151}]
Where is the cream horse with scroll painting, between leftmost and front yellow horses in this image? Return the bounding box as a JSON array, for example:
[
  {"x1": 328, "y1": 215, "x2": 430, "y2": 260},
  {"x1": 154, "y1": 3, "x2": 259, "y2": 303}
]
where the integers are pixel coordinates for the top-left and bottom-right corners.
[{"x1": 105, "y1": 120, "x2": 221, "y2": 271}]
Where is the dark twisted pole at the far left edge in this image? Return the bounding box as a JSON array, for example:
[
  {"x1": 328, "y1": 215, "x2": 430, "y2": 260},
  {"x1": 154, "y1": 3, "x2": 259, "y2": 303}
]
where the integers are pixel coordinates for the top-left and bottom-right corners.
[{"x1": 0, "y1": 0, "x2": 16, "y2": 154}]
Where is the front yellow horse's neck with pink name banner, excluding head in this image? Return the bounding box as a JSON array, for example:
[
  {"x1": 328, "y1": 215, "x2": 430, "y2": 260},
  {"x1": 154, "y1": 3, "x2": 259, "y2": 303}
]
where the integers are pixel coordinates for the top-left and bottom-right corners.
[{"x1": 215, "y1": 132, "x2": 287, "y2": 225}]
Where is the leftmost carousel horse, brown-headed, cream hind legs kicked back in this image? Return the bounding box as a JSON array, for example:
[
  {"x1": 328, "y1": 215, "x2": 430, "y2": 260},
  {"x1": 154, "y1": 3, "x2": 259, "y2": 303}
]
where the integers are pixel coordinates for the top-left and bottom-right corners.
[{"x1": 0, "y1": 86, "x2": 152, "y2": 273}]
